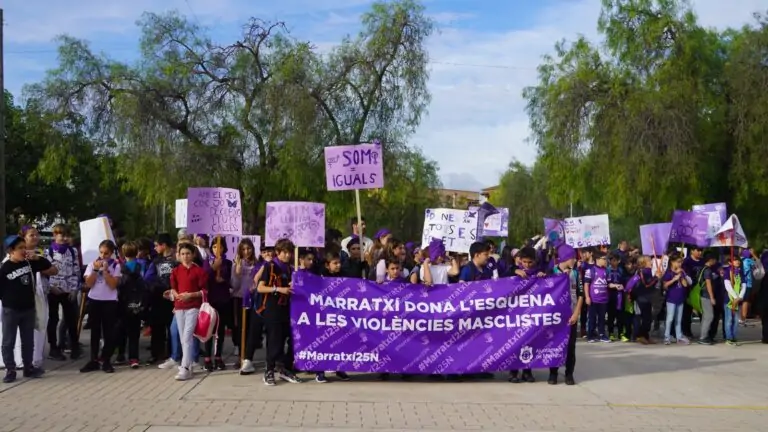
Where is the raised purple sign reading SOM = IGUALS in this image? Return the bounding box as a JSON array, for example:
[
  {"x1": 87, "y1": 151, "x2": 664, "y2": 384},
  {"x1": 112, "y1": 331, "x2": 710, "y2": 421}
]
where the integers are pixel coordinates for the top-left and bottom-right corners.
[{"x1": 325, "y1": 144, "x2": 384, "y2": 191}]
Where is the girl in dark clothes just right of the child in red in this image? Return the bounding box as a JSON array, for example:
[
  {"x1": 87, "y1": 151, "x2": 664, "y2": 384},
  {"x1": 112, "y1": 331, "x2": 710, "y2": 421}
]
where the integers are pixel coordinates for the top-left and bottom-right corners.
[{"x1": 203, "y1": 236, "x2": 233, "y2": 372}]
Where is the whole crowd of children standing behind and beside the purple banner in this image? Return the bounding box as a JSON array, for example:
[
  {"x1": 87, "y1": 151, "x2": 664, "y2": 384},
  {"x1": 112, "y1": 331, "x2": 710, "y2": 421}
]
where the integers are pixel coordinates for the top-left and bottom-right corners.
[{"x1": 0, "y1": 218, "x2": 768, "y2": 386}]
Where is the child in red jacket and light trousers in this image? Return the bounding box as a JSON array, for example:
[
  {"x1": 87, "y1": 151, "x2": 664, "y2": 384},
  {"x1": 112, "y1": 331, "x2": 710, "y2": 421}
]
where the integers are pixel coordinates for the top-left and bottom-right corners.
[{"x1": 170, "y1": 243, "x2": 208, "y2": 381}]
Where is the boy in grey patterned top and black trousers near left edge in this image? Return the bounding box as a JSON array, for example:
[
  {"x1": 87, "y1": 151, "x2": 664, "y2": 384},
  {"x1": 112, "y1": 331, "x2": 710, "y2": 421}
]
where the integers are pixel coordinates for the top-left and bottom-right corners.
[{"x1": 45, "y1": 224, "x2": 81, "y2": 361}]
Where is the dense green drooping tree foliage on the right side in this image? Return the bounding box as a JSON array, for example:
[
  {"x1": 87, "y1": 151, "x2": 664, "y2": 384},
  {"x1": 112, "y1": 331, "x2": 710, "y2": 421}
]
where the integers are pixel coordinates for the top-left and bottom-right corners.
[{"x1": 499, "y1": 0, "x2": 768, "y2": 245}]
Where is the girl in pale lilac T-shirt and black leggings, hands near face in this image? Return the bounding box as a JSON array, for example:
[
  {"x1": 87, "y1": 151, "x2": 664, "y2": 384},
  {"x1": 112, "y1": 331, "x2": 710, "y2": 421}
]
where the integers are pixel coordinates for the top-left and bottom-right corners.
[{"x1": 80, "y1": 240, "x2": 122, "y2": 373}]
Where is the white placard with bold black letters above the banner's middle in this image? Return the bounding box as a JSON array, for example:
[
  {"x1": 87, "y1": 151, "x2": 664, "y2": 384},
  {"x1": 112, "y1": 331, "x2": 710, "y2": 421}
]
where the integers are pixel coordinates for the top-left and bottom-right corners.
[{"x1": 421, "y1": 208, "x2": 477, "y2": 253}]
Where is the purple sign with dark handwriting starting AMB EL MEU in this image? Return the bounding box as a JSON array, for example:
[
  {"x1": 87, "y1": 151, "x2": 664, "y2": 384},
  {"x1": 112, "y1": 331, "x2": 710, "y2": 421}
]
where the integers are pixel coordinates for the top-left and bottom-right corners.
[{"x1": 187, "y1": 188, "x2": 243, "y2": 236}]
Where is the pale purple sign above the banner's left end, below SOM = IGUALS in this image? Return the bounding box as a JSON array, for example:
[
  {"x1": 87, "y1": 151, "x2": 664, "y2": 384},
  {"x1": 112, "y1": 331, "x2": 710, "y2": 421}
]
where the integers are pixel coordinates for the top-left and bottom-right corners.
[{"x1": 264, "y1": 201, "x2": 325, "y2": 247}]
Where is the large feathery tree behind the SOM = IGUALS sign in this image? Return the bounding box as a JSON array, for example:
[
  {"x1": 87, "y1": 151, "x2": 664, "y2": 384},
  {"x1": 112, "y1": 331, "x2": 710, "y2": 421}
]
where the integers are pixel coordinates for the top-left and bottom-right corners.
[{"x1": 26, "y1": 0, "x2": 439, "y2": 236}]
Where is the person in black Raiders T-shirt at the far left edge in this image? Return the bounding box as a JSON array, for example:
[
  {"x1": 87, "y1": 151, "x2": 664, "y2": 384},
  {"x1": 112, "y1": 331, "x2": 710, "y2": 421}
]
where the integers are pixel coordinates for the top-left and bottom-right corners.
[{"x1": 0, "y1": 235, "x2": 57, "y2": 383}]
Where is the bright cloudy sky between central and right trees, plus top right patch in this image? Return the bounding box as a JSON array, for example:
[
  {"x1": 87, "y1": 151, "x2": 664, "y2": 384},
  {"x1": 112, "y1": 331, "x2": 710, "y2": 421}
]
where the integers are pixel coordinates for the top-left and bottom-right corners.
[{"x1": 413, "y1": 0, "x2": 768, "y2": 189}]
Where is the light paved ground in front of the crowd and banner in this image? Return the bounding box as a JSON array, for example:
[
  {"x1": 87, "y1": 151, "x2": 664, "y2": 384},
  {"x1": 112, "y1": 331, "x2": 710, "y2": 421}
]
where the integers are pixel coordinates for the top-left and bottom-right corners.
[{"x1": 0, "y1": 329, "x2": 768, "y2": 432}]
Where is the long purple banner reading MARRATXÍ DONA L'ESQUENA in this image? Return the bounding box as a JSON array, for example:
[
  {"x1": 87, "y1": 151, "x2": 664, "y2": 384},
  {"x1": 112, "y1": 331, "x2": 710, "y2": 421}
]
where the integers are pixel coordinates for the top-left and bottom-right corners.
[{"x1": 291, "y1": 271, "x2": 571, "y2": 374}]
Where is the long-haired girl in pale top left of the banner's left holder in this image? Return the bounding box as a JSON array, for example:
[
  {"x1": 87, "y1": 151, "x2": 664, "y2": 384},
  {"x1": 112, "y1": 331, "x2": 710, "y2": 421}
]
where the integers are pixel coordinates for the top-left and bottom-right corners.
[{"x1": 231, "y1": 238, "x2": 257, "y2": 368}]
